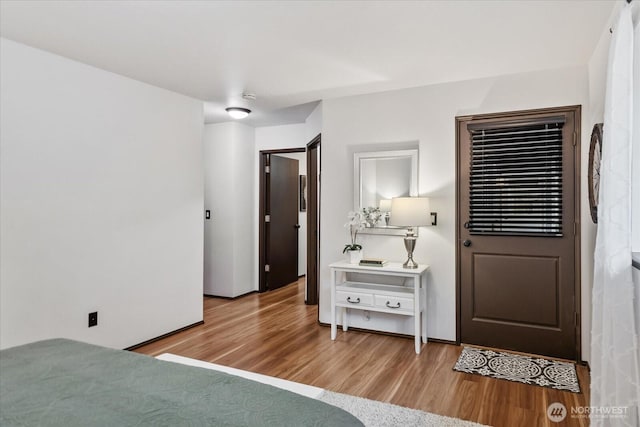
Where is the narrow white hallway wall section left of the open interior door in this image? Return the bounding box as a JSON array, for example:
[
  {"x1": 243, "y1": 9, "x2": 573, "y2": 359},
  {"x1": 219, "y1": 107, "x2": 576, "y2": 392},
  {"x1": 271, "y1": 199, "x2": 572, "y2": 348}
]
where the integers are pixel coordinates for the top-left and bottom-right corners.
[{"x1": 203, "y1": 122, "x2": 258, "y2": 298}]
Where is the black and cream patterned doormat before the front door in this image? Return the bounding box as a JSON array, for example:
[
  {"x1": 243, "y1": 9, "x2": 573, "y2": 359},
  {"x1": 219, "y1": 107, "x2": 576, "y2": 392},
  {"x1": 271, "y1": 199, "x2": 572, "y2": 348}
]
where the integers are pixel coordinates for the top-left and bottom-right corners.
[{"x1": 453, "y1": 347, "x2": 580, "y2": 393}]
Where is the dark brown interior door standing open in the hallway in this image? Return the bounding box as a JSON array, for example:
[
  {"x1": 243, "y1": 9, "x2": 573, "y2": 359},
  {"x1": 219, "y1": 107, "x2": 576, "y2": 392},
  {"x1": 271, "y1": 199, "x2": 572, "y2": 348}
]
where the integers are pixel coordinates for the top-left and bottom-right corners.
[{"x1": 266, "y1": 154, "x2": 300, "y2": 290}]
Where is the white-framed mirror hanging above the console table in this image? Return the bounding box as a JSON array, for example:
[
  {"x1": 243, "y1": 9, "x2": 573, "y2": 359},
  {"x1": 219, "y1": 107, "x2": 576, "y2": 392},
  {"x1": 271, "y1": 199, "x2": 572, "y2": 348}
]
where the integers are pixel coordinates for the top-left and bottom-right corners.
[{"x1": 353, "y1": 149, "x2": 418, "y2": 236}]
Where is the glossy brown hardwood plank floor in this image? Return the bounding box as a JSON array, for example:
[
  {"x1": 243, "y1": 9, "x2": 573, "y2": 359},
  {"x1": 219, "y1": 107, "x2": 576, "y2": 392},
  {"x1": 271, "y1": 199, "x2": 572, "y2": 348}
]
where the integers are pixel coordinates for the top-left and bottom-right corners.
[{"x1": 136, "y1": 279, "x2": 589, "y2": 427}]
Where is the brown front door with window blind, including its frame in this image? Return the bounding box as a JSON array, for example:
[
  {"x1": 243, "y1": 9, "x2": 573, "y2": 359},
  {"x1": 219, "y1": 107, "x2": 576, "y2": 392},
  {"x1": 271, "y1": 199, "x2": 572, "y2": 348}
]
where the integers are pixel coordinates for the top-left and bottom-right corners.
[{"x1": 456, "y1": 107, "x2": 580, "y2": 359}]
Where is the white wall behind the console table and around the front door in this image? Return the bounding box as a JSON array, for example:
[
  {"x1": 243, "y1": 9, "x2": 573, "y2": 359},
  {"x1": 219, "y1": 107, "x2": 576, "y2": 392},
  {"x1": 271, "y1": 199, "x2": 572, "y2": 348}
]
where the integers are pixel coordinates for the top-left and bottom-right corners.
[{"x1": 320, "y1": 67, "x2": 592, "y2": 360}]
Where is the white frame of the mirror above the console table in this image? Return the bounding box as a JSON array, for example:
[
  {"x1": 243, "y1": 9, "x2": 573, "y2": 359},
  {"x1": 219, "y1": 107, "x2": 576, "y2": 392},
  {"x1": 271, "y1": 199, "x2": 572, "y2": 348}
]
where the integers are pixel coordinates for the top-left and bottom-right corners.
[{"x1": 353, "y1": 148, "x2": 418, "y2": 236}]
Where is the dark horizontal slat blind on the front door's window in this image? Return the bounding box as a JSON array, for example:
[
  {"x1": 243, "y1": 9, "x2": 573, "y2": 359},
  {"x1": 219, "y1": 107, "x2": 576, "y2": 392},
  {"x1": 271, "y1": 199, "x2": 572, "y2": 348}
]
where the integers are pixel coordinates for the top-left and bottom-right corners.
[{"x1": 467, "y1": 118, "x2": 564, "y2": 237}]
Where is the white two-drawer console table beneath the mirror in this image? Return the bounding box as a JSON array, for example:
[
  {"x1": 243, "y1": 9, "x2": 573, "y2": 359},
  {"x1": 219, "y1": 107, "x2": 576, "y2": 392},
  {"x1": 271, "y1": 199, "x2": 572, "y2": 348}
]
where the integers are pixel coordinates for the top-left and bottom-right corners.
[{"x1": 329, "y1": 262, "x2": 429, "y2": 354}]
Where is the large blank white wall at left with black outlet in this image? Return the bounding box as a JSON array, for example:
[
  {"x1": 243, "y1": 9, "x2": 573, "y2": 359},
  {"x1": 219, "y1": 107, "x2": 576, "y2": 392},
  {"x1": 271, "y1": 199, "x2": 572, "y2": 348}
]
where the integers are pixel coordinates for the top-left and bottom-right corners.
[{"x1": 0, "y1": 39, "x2": 203, "y2": 348}]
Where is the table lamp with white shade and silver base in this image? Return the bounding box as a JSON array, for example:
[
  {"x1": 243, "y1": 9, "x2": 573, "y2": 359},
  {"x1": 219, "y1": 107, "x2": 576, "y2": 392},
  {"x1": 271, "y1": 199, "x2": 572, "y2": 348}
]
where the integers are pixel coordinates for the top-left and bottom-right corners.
[{"x1": 389, "y1": 197, "x2": 432, "y2": 268}]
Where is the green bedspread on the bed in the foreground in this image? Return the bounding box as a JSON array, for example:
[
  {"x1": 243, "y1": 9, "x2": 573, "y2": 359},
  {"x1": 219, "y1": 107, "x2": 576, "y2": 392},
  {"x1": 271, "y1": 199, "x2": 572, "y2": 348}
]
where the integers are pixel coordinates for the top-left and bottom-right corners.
[{"x1": 0, "y1": 339, "x2": 362, "y2": 427}]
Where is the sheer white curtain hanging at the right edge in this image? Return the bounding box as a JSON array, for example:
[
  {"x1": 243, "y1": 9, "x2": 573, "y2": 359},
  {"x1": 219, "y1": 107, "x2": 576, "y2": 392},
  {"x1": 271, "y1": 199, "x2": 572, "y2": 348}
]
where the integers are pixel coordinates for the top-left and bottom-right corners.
[{"x1": 590, "y1": 0, "x2": 640, "y2": 427}]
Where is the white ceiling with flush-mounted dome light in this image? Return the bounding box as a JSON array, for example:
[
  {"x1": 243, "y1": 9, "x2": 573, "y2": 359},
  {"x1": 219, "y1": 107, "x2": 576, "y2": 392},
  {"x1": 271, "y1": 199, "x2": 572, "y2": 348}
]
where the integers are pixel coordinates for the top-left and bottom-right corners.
[{"x1": 0, "y1": 0, "x2": 615, "y2": 126}]
